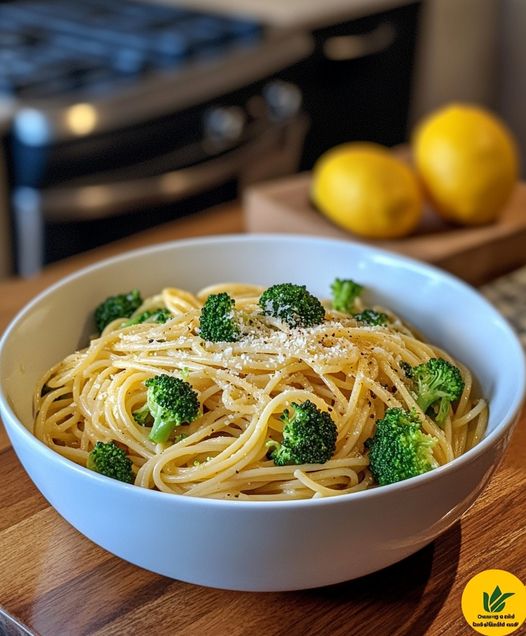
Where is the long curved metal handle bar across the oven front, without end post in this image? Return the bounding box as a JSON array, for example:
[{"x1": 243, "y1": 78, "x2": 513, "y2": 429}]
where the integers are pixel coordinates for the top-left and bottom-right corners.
[{"x1": 35, "y1": 131, "x2": 273, "y2": 223}]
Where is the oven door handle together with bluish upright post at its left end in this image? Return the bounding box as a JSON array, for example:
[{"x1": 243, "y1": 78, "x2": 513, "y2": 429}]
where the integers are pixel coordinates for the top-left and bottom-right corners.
[{"x1": 12, "y1": 113, "x2": 308, "y2": 276}]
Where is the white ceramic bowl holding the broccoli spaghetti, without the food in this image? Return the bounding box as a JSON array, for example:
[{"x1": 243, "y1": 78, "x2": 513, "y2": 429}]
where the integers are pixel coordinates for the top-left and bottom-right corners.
[{"x1": 0, "y1": 236, "x2": 525, "y2": 590}]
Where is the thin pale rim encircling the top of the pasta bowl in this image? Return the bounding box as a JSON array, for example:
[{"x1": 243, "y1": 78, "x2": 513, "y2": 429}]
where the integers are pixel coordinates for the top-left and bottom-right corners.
[{"x1": 0, "y1": 233, "x2": 526, "y2": 510}]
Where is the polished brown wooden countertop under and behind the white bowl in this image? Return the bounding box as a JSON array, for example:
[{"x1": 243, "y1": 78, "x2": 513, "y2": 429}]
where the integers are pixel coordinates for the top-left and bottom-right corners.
[{"x1": 0, "y1": 206, "x2": 526, "y2": 636}]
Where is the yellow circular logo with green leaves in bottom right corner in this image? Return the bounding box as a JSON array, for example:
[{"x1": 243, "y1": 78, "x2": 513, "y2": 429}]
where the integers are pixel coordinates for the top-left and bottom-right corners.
[{"x1": 462, "y1": 570, "x2": 526, "y2": 636}]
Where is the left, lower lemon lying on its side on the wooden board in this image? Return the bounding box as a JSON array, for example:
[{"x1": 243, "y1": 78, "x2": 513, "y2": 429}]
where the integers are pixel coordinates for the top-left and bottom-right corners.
[{"x1": 311, "y1": 142, "x2": 422, "y2": 239}]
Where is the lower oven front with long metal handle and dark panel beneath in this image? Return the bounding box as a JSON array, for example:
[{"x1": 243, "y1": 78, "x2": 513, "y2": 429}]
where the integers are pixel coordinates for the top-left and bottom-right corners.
[{"x1": 12, "y1": 107, "x2": 307, "y2": 276}]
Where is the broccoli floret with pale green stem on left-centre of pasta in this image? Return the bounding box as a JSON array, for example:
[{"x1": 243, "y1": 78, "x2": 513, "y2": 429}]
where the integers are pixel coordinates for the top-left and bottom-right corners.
[{"x1": 133, "y1": 373, "x2": 200, "y2": 444}]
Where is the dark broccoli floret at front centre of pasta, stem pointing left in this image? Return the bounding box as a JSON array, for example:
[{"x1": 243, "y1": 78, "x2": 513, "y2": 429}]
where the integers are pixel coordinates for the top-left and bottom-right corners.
[{"x1": 267, "y1": 400, "x2": 338, "y2": 466}]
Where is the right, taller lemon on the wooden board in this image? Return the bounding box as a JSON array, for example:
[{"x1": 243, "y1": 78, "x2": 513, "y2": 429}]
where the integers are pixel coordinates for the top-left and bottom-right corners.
[{"x1": 413, "y1": 104, "x2": 519, "y2": 225}]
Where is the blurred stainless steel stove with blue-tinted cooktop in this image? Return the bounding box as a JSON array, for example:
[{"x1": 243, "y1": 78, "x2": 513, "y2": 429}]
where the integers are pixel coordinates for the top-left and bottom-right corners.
[{"x1": 0, "y1": 0, "x2": 311, "y2": 275}]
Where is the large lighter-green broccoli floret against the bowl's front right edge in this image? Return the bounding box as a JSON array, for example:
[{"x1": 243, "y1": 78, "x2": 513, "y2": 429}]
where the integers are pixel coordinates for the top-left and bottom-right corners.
[{"x1": 365, "y1": 408, "x2": 437, "y2": 486}]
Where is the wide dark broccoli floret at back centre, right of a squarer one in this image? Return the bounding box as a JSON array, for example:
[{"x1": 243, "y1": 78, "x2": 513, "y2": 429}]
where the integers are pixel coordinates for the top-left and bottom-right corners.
[{"x1": 259, "y1": 283, "x2": 325, "y2": 328}]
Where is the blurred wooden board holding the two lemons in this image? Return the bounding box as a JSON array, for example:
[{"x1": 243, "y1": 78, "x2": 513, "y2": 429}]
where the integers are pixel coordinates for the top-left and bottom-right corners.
[{"x1": 244, "y1": 173, "x2": 526, "y2": 285}]
